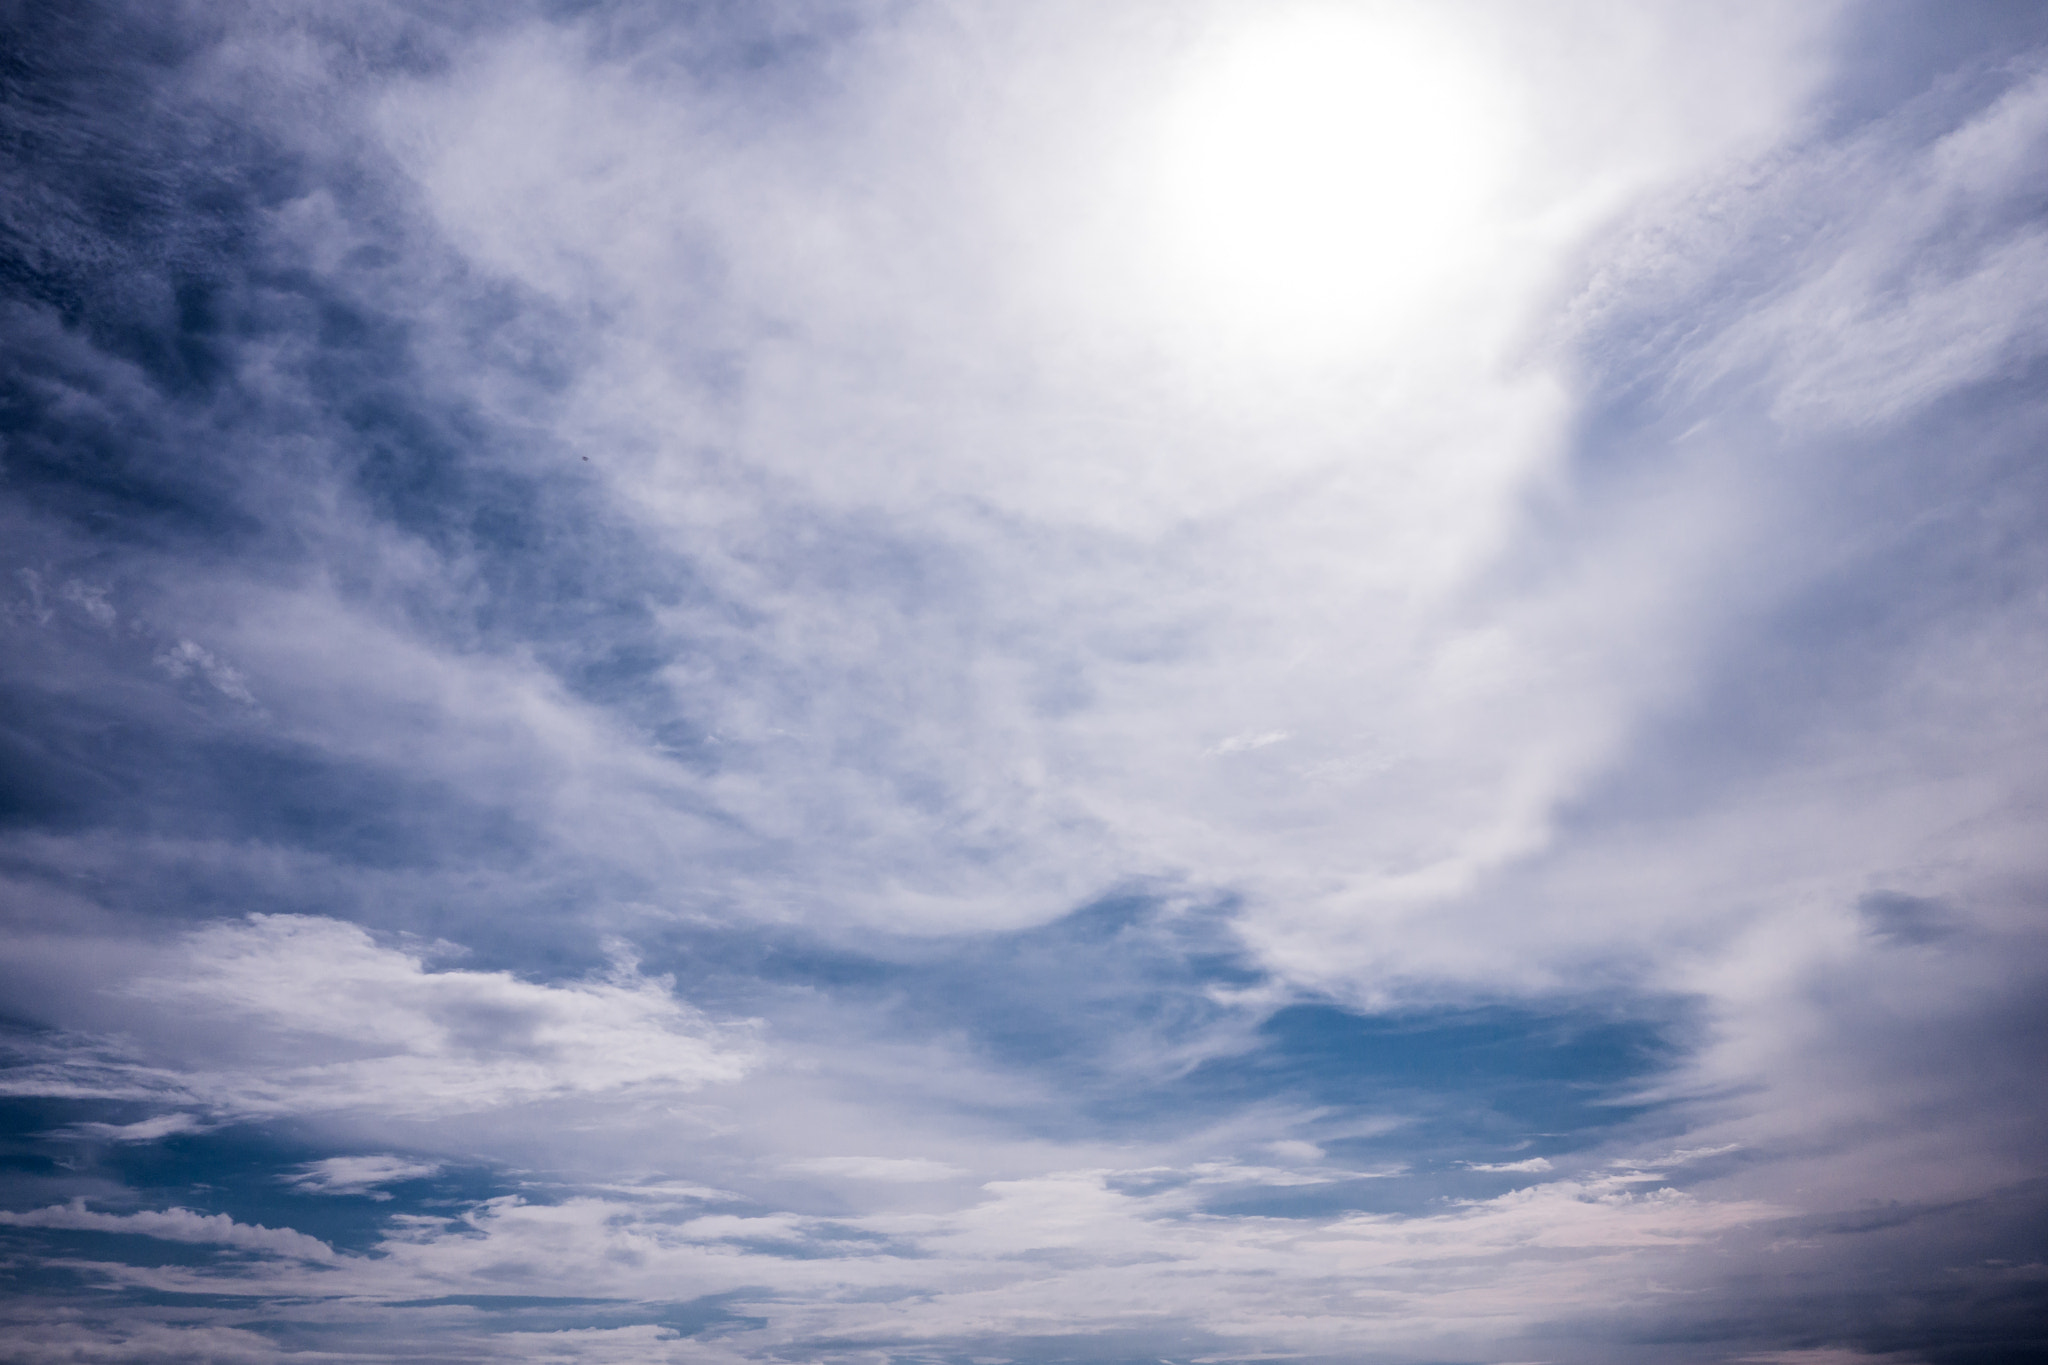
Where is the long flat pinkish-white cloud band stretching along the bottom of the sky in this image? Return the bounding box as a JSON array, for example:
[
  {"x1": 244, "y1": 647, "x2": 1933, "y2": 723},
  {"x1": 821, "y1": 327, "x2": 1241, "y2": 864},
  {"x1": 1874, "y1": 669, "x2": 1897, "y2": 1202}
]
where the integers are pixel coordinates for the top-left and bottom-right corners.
[{"x1": 172, "y1": 1171, "x2": 1782, "y2": 1353}]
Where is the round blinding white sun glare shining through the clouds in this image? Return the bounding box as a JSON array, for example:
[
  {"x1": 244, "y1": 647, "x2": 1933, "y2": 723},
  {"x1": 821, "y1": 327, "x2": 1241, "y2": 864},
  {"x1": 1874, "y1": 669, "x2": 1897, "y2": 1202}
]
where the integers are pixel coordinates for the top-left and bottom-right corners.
[{"x1": 1153, "y1": 8, "x2": 1505, "y2": 350}]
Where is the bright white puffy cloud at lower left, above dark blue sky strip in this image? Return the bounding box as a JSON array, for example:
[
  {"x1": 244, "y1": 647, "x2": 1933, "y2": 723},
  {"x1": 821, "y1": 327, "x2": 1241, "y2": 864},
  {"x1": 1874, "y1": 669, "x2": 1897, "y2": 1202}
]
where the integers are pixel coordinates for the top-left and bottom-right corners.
[{"x1": 16, "y1": 915, "x2": 754, "y2": 1121}]
